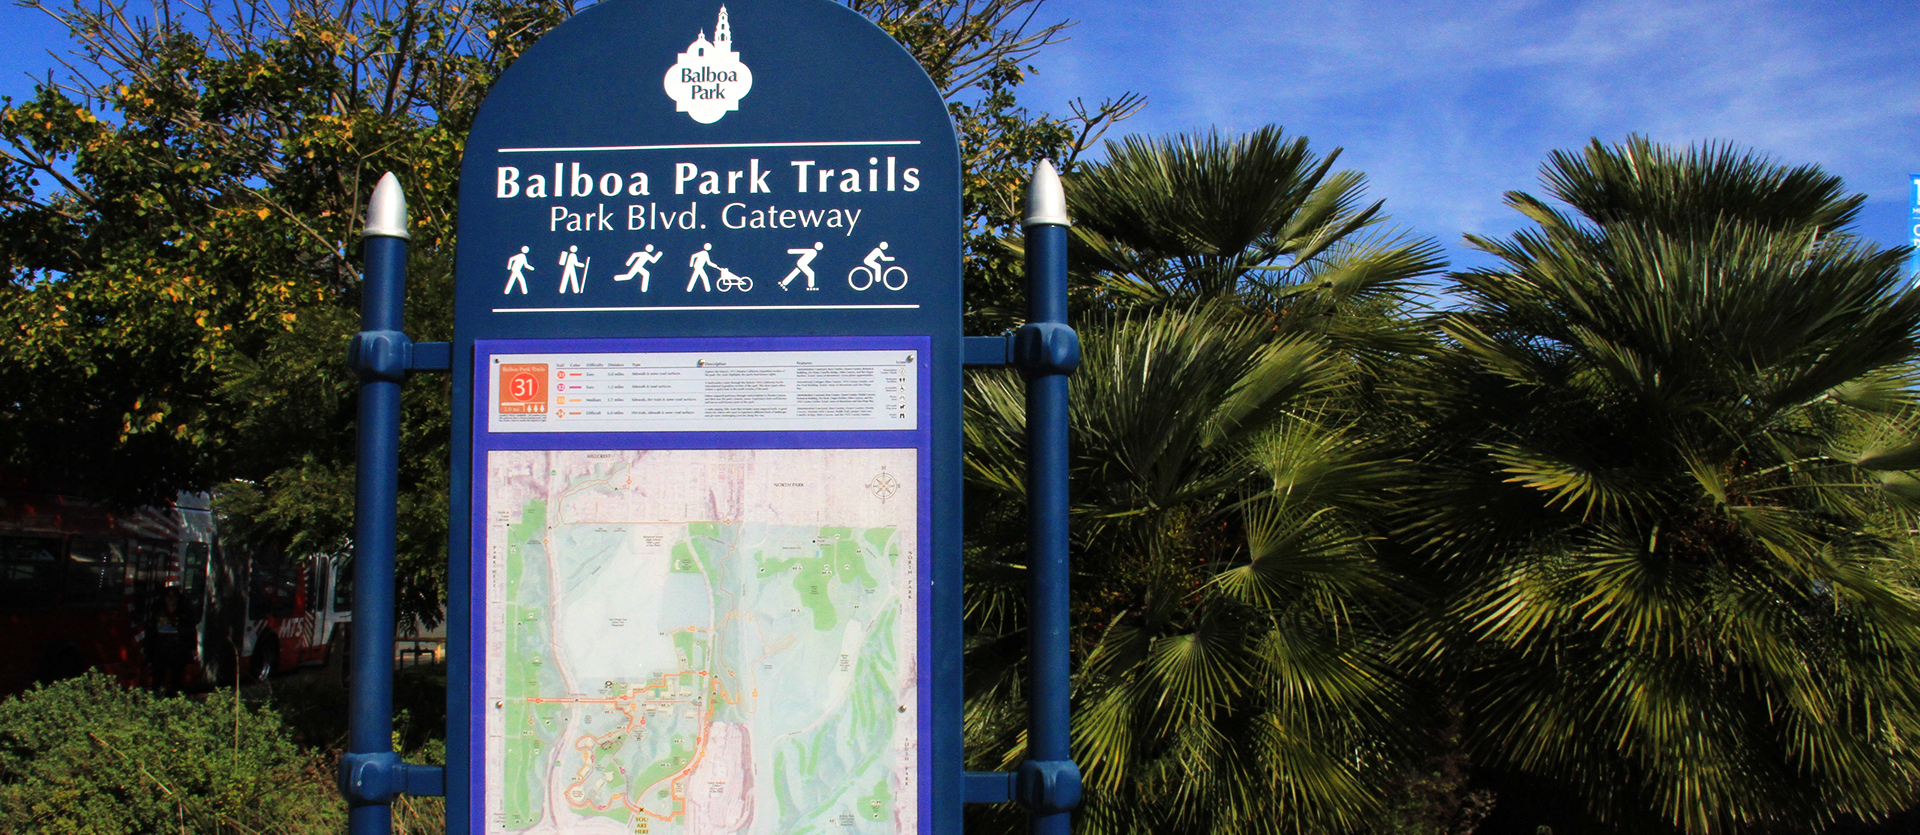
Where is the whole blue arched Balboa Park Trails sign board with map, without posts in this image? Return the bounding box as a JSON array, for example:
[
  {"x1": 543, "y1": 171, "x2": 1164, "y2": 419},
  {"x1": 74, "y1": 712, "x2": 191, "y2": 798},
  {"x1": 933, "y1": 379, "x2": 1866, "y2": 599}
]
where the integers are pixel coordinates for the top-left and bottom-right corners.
[{"x1": 445, "y1": 0, "x2": 962, "y2": 835}]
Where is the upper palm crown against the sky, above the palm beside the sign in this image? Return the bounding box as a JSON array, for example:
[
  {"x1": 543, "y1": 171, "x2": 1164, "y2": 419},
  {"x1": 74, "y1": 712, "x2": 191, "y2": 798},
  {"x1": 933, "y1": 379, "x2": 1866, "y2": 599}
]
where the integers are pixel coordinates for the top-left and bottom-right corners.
[{"x1": 1066, "y1": 125, "x2": 1440, "y2": 316}]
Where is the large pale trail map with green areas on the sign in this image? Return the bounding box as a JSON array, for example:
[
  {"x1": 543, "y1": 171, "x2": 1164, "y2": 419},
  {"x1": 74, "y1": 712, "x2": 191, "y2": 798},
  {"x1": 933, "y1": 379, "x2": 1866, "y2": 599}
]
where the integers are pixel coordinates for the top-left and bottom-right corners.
[{"x1": 484, "y1": 449, "x2": 922, "y2": 835}]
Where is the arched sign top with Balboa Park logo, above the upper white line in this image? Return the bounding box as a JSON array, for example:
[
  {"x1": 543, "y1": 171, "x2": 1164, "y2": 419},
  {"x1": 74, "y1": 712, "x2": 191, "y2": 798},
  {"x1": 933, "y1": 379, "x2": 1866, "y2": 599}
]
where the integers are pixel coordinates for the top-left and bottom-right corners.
[{"x1": 474, "y1": 0, "x2": 952, "y2": 150}]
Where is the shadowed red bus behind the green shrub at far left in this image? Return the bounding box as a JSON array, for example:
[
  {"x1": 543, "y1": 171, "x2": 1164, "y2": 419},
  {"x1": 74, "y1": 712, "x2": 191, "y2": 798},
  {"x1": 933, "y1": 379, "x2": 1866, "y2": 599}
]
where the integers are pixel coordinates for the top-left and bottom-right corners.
[{"x1": 0, "y1": 491, "x2": 351, "y2": 695}]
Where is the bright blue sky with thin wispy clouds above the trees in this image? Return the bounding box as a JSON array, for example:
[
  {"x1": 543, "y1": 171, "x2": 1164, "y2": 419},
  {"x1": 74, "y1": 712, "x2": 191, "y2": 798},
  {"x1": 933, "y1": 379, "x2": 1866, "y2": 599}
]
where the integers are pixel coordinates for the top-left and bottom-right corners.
[{"x1": 0, "y1": 0, "x2": 1920, "y2": 265}]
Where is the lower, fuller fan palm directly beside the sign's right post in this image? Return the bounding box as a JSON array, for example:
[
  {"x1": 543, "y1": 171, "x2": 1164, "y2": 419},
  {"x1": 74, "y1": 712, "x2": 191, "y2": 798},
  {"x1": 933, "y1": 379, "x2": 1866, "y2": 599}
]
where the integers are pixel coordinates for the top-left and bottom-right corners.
[{"x1": 968, "y1": 303, "x2": 1413, "y2": 833}]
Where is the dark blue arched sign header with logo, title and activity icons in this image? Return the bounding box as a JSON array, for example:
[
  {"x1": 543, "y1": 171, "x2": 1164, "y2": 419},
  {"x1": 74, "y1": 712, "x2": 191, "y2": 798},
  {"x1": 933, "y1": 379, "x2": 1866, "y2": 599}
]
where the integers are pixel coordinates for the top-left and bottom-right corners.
[{"x1": 455, "y1": 0, "x2": 960, "y2": 340}]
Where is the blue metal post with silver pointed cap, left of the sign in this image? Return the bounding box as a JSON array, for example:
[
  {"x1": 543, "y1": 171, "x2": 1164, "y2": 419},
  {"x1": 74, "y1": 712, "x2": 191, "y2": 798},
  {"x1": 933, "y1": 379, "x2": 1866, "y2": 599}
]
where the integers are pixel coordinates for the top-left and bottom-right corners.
[{"x1": 340, "y1": 175, "x2": 413, "y2": 835}]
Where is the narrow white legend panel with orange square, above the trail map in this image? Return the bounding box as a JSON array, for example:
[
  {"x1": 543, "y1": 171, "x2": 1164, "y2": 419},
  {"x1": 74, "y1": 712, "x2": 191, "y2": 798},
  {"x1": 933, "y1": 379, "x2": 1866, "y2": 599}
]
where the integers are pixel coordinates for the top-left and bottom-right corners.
[{"x1": 488, "y1": 351, "x2": 920, "y2": 432}]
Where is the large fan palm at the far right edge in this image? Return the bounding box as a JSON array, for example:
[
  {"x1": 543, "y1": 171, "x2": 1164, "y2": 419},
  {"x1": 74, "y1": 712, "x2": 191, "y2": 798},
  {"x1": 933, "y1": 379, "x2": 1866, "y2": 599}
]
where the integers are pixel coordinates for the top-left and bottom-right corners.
[{"x1": 1400, "y1": 138, "x2": 1920, "y2": 833}]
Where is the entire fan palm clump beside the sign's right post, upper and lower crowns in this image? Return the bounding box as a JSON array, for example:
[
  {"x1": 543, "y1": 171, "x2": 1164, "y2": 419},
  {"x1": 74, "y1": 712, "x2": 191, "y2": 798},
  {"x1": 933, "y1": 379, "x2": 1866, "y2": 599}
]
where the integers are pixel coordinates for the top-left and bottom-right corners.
[{"x1": 968, "y1": 129, "x2": 1440, "y2": 833}]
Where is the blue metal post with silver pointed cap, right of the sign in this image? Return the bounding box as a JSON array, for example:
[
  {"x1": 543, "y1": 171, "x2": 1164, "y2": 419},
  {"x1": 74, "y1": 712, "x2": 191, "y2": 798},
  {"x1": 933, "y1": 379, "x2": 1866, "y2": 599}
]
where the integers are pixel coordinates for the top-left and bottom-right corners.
[{"x1": 1014, "y1": 161, "x2": 1081, "y2": 835}]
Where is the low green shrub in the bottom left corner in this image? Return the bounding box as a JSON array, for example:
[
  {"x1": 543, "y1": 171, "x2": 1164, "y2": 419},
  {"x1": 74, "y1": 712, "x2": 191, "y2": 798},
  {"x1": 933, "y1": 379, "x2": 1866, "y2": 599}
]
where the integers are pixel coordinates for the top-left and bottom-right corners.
[{"x1": 0, "y1": 674, "x2": 346, "y2": 835}]
